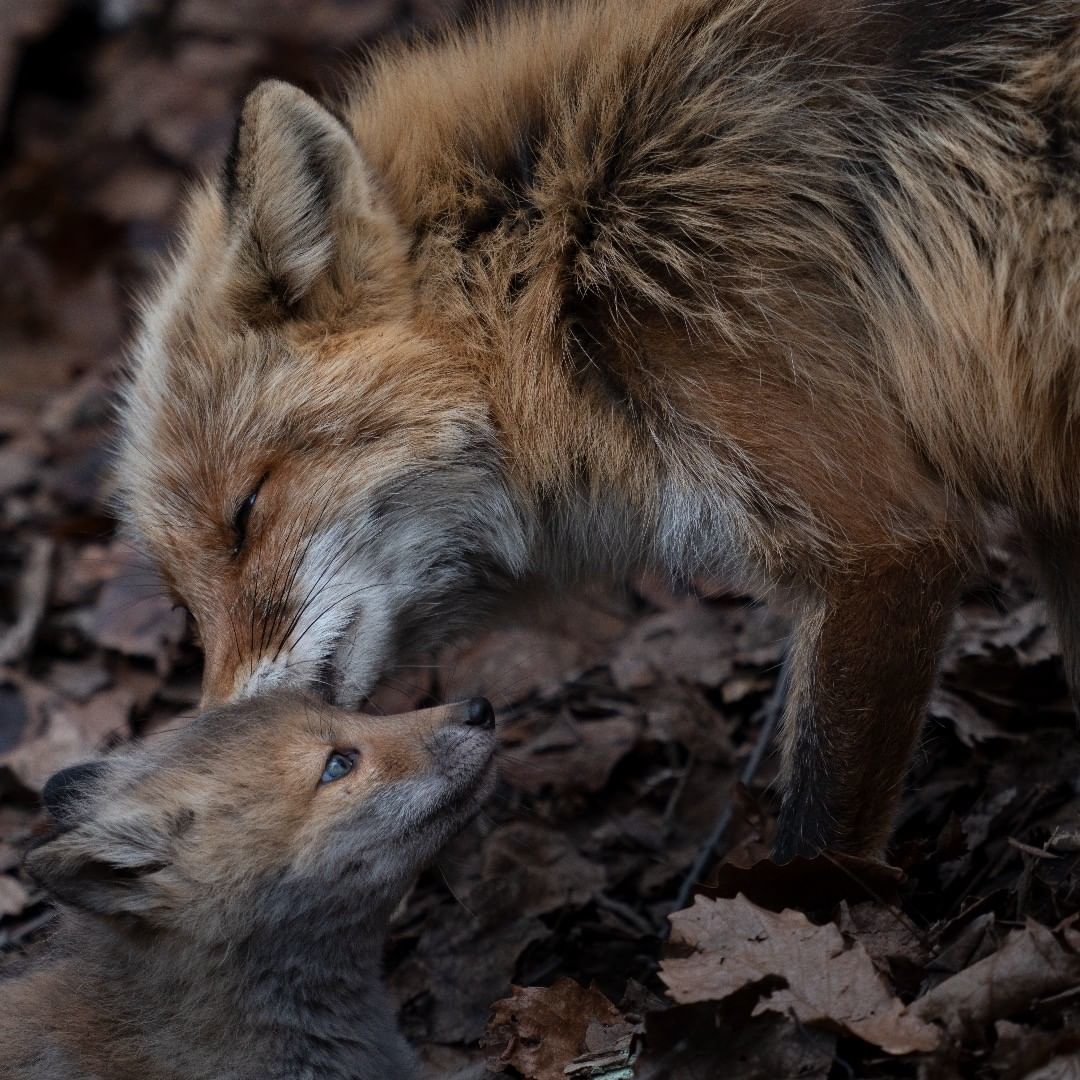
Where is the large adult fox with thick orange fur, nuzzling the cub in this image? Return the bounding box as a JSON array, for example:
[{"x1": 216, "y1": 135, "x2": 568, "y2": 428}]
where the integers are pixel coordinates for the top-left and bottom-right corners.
[{"x1": 120, "y1": 0, "x2": 1080, "y2": 855}]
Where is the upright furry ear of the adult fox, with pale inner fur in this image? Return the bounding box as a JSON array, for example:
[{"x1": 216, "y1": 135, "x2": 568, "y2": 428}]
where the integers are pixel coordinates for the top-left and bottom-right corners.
[{"x1": 224, "y1": 81, "x2": 403, "y2": 322}]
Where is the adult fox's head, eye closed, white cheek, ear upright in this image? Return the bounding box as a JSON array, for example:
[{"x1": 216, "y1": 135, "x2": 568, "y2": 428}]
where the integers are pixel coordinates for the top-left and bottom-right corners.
[{"x1": 118, "y1": 82, "x2": 525, "y2": 706}]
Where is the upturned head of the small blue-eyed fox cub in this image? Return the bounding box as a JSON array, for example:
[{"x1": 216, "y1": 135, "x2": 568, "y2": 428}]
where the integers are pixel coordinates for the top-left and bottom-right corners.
[{"x1": 26, "y1": 694, "x2": 495, "y2": 943}]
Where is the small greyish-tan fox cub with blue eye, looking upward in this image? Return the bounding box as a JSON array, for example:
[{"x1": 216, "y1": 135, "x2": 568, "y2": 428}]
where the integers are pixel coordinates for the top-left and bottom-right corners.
[{"x1": 0, "y1": 694, "x2": 495, "y2": 1080}]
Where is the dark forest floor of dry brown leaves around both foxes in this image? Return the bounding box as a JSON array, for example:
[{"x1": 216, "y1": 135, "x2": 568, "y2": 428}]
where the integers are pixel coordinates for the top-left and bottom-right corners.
[{"x1": 0, "y1": 0, "x2": 1080, "y2": 1080}]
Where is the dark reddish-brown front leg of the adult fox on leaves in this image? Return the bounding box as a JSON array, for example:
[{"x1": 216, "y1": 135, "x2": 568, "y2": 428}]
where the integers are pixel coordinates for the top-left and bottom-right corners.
[{"x1": 773, "y1": 549, "x2": 958, "y2": 862}]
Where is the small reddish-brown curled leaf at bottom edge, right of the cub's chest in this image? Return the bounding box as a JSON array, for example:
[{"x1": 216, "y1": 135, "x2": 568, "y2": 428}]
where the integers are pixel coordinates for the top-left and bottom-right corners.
[{"x1": 486, "y1": 978, "x2": 633, "y2": 1080}]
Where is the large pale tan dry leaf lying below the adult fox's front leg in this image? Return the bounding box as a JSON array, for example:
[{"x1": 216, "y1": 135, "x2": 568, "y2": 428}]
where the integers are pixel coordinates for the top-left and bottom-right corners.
[{"x1": 660, "y1": 896, "x2": 940, "y2": 1054}]
